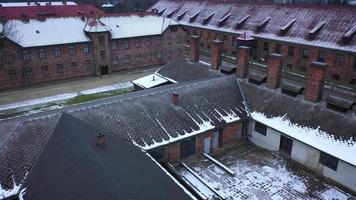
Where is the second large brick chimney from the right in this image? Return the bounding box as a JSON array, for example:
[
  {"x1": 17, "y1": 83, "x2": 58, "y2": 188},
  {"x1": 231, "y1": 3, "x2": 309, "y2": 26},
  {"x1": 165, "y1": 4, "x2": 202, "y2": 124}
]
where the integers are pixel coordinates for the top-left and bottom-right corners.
[{"x1": 267, "y1": 53, "x2": 283, "y2": 89}]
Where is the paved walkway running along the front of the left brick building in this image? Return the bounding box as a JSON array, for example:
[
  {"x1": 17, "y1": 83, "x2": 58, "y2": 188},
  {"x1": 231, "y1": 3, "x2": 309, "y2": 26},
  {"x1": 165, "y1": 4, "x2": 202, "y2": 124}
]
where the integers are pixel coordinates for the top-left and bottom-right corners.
[{"x1": 0, "y1": 67, "x2": 158, "y2": 105}]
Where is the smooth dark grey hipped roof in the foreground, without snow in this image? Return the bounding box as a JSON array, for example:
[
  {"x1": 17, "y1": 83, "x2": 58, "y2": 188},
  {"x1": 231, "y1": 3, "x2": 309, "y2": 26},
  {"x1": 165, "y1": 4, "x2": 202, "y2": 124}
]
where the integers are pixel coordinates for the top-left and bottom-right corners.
[{"x1": 22, "y1": 113, "x2": 191, "y2": 200}]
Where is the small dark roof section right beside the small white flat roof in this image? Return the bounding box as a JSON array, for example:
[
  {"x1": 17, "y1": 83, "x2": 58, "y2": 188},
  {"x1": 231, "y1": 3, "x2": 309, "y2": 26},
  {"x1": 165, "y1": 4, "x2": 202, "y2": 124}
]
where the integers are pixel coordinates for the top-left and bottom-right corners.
[{"x1": 156, "y1": 59, "x2": 221, "y2": 82}]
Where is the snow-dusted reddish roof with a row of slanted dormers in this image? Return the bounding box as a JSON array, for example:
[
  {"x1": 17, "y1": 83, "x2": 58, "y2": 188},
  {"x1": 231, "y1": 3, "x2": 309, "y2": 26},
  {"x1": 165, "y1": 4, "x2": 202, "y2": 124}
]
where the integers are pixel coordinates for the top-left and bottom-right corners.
[{"x1": 151, "y1": 0, "x2": 356, "y2": 52}]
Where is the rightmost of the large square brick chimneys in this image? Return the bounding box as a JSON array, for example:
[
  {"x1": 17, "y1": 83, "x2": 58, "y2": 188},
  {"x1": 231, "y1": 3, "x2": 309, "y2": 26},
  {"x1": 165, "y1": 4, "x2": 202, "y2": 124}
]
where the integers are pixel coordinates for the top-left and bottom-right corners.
[{"x1": 304, "y1": 62, "x2": 328, "y2": 102}]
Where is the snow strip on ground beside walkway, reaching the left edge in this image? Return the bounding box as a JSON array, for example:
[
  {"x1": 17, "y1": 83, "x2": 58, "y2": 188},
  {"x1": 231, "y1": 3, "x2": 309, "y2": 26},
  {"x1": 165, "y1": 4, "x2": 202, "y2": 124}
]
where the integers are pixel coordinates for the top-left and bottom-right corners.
[{"x1": 0, "y1": 92, "x2": 78, "y2": 111}]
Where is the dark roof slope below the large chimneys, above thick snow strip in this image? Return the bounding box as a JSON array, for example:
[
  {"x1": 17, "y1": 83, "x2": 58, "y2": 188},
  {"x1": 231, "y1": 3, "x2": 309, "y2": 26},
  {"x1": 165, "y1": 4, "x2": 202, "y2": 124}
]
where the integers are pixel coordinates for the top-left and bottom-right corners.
[{"x1": 240, "y1": 81, "x2": 356, "y2": 140}]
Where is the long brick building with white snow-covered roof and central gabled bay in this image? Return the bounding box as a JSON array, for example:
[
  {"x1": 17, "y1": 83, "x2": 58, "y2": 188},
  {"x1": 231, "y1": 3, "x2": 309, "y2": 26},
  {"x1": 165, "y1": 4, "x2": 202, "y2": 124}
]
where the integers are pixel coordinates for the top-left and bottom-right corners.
[{"x1": 0, "y1": 13, "x2": 184, "y2": 89}]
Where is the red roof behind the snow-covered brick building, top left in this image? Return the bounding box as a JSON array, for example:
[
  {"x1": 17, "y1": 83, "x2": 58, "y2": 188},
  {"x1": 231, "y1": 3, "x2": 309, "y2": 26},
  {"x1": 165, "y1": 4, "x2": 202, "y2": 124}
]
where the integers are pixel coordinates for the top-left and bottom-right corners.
[{"x1": 0, "y1": 4, "x2": 104, "y2": 19}]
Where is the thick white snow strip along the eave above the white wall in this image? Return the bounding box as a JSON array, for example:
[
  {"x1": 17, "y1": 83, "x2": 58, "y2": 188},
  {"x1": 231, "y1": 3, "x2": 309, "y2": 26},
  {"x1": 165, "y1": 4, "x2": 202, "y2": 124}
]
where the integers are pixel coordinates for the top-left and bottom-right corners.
[{"x1": 251, "y1": 112, "x2": 356, "y2": 166}]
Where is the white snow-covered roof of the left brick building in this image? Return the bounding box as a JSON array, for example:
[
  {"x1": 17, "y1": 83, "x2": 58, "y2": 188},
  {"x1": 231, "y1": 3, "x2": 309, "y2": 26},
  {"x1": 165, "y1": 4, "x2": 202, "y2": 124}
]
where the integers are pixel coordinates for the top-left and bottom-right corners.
[{"x1": 7, "y1": 16, "x2": 176, "y2": 47}]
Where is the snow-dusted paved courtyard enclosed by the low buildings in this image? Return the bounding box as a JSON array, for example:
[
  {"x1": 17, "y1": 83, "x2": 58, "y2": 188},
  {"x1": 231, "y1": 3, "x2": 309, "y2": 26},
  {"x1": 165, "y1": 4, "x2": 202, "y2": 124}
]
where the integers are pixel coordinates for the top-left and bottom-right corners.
[{"x1": 177, "y1": 142, "x2": 355, "y2": 200}]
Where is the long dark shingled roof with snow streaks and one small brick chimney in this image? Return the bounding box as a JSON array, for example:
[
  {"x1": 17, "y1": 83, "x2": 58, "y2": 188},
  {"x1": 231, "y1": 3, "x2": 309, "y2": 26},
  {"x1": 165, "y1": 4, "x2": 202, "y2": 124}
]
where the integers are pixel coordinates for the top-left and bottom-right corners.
[{"x1": 0, "y1": 76, "x2": 247, "y2": 188}]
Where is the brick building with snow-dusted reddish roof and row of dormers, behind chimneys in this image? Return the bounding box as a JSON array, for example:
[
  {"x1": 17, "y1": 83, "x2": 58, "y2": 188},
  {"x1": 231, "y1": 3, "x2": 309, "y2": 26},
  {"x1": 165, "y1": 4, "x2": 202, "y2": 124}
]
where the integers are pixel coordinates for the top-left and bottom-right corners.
[{"x1": 151, "y1": 0, "x2": 356, "y2": 87}]
